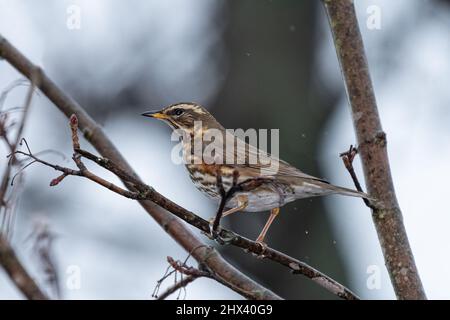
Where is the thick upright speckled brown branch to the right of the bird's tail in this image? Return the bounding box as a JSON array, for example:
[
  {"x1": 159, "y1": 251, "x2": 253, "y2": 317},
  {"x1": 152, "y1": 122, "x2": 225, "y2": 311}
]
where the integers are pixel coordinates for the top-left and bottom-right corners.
[{"x1": 323, "y1": 0, "x2": 426, "y2": 299}]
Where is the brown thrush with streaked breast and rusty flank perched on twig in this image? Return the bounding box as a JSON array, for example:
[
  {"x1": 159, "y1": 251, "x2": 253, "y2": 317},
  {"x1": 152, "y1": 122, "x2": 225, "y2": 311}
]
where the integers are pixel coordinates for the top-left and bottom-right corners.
[{"x1": 142, "y1": 103, "x2": 367, "y2": 243}]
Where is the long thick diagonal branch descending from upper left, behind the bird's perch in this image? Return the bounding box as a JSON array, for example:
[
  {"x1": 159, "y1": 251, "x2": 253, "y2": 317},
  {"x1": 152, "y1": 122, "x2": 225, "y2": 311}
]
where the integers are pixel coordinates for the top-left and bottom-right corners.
[{"x1": 0, "y1": 35, "x2": 281, "y2": 299}]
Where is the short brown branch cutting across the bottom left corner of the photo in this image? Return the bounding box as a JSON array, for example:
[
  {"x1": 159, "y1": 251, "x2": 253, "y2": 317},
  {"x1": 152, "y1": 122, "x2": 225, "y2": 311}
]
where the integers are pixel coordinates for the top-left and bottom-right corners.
[{"x1": 0, "y1": 234, "x2": 48, "y2": 300}]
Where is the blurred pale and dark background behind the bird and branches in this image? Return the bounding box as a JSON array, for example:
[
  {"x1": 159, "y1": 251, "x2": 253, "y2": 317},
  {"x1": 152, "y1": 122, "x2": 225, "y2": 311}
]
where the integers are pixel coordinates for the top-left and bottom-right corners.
[{"x1": 0, "y1": 0, "x2": 450, "y2": 299}]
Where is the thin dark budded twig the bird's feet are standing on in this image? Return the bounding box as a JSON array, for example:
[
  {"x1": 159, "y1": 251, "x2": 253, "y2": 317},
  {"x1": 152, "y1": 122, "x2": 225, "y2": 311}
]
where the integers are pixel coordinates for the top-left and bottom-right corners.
[{"x1": 11, "y1": 115, "x2": 358, "y2": 300}]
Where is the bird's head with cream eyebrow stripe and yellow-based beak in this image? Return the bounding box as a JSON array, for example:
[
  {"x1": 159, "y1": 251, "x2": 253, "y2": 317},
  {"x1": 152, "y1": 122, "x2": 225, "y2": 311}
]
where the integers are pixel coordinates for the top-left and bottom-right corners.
[{"x1": 142, "y1": 102, "x2": 223, "y2": 132}]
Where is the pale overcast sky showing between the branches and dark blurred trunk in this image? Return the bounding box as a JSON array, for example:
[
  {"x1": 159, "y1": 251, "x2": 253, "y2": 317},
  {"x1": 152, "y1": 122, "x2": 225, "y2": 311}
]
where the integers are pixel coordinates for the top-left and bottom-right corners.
[{"x1": 0, "y1": 0, "x2": 450, "y2": 299}]
